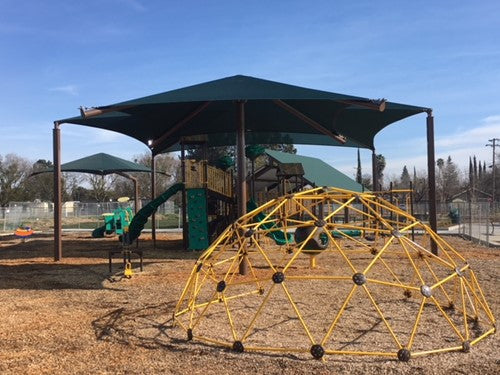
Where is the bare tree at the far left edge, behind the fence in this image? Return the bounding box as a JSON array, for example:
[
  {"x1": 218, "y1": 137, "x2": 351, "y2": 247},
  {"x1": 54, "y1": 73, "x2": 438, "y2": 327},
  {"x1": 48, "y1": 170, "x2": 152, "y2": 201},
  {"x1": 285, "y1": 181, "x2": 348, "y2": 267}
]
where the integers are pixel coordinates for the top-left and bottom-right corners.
[{"x1": 0, "y1": 154, "x2": 31, "y2": 207}]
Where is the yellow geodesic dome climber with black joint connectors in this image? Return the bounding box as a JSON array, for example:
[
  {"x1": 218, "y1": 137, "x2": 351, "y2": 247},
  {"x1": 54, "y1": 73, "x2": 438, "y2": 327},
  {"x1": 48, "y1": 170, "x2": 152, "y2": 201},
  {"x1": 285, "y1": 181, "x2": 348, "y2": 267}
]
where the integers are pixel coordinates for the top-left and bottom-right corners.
[{"x1": 174, "y1": 188, "x2": 495, "y2": 361}]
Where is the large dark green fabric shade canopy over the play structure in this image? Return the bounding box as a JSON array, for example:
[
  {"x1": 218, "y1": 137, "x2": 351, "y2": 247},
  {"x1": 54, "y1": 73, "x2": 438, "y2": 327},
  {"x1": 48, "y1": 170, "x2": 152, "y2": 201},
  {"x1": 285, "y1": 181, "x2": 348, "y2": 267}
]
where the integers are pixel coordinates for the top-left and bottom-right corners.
[{"x1": 54, "y1": 75, "x2": 434, "y2": 259}]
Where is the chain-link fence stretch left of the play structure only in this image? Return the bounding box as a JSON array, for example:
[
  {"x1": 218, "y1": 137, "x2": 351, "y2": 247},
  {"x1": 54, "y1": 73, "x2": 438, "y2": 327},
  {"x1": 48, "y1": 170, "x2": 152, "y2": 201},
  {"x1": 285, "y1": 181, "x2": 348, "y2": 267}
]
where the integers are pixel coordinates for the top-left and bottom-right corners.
[{"x1": 0, "y1": 201, "x2": 182, "y2": 233}]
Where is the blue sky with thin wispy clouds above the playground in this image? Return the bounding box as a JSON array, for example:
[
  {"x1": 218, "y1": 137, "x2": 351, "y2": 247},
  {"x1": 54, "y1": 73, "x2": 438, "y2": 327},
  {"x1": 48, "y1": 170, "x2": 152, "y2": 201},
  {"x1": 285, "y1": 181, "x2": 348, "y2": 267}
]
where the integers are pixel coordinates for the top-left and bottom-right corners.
[{"x1": 0, "y1": 0, "x2": 500, "y2": 182}]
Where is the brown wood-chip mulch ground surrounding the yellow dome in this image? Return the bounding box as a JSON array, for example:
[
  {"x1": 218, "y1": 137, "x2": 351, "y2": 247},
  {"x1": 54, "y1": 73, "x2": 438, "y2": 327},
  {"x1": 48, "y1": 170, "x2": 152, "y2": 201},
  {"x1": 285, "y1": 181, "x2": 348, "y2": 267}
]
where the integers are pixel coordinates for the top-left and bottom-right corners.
[{"x1": 0, "y1": 233, "x2": 500, "y2": 374}]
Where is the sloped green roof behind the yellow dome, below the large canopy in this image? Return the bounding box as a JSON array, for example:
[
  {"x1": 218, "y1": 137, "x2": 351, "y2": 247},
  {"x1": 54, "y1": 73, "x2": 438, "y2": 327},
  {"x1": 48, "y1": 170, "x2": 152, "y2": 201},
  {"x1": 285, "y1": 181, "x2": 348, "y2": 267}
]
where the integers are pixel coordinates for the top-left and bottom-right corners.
[{"x1": 266, "y1": 150, "x2": 363, "y2": 192}]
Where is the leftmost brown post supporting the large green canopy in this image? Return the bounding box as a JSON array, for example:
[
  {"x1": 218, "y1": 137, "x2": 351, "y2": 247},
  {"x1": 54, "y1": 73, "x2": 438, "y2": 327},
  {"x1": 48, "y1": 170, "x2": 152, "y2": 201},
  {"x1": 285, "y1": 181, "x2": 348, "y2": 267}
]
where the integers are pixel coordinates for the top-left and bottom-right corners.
[{"x1": 52, "y1": 121, "x2": 62, "y2": 262}]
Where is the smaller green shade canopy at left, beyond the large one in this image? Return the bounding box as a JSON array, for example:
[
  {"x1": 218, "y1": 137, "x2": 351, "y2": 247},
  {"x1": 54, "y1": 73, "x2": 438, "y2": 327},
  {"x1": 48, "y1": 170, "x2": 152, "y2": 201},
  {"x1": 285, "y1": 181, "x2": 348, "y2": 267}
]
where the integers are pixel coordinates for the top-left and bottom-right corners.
[{"x1": 33, "y1": 152, "x2": 151, "y2": 176}]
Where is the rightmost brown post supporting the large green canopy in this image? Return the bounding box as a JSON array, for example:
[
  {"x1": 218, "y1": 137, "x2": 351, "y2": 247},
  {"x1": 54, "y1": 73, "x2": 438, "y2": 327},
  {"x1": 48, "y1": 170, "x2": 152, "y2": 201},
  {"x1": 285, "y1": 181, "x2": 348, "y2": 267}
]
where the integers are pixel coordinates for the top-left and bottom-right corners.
[{"x1": 427, "y1": 110, "x2": 438, "y2": 255}]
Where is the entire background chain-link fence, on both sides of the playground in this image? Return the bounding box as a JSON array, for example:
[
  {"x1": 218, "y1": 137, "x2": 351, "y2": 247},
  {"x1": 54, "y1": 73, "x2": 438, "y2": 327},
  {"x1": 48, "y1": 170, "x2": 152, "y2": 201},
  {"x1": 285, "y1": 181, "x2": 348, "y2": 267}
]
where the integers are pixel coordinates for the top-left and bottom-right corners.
[{"x1": 0, "y1": 201, "x2": 500, "y2": 246}]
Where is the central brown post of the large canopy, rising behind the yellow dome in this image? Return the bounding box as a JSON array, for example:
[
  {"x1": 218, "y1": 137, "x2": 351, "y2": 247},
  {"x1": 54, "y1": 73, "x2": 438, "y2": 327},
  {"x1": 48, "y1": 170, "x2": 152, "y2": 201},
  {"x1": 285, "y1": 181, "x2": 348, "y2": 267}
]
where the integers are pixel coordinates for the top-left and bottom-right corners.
[{"x1": 236, "y1": 100, "x2": 248, "y2": 275}]
